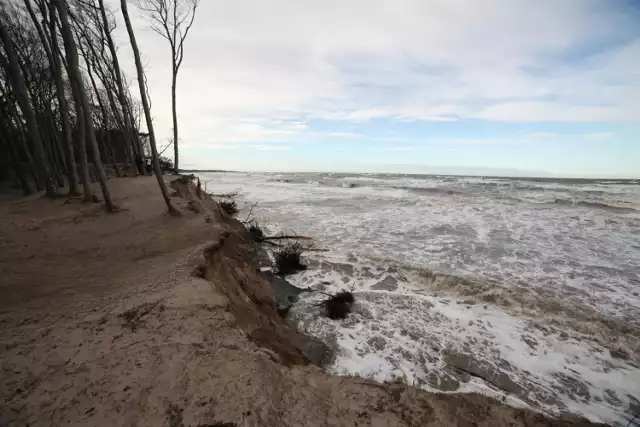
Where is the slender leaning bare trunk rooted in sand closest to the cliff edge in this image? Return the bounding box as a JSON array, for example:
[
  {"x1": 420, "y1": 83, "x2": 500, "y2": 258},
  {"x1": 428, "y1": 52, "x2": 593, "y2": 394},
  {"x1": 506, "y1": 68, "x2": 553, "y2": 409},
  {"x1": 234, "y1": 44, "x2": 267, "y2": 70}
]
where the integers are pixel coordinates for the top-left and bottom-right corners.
[{"x1": 120, "y1": 0, "x2": 181, "y2": 216}]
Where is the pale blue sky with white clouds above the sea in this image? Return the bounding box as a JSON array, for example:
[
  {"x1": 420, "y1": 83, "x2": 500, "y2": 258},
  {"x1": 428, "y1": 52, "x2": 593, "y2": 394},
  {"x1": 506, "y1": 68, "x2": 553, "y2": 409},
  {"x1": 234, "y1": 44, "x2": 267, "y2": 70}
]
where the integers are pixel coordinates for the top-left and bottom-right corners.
[{"x1": 110, "y1": 0, "x2": 640, "y2": 178}]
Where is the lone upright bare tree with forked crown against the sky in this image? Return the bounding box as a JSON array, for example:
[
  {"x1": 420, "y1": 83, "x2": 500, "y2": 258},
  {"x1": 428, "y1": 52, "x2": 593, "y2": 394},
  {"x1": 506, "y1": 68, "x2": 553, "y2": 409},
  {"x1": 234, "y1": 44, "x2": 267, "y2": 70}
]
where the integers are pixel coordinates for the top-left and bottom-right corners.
[{"x1": 138, "y1": 0, "x2": 200, "y2": 173}]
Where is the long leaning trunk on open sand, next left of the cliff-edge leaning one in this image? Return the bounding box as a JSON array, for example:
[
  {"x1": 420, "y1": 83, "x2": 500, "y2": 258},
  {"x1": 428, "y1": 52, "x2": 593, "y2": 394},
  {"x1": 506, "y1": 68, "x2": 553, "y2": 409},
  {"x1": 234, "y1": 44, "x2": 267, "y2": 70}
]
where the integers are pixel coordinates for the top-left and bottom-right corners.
[{"x1": 54, "y1": 0, "x2": 117, "y2": 212}]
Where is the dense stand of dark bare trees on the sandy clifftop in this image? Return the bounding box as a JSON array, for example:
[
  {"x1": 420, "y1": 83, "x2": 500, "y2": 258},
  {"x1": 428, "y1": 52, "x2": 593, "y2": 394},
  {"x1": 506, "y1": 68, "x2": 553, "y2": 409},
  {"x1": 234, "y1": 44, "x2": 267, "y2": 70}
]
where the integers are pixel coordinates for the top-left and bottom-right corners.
[{"x1": 0, "y1": 0, "x2": 198, "y2": 215}]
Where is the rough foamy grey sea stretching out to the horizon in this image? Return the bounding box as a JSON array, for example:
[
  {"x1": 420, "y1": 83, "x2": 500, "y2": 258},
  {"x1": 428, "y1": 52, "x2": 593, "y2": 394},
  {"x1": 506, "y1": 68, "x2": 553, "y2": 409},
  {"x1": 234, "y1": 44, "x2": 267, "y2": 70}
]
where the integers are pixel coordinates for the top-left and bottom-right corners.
[{"x1": 200, "y1": 172, "x2": 640, "y2": 426}]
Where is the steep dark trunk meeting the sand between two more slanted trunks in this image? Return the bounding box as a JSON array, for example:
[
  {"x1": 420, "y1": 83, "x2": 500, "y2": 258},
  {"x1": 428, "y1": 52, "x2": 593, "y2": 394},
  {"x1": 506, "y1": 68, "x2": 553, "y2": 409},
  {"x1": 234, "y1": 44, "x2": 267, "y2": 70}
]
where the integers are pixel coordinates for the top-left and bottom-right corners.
[{"x1": 49, "y1": 3, "x2": 80, "y2": 197}]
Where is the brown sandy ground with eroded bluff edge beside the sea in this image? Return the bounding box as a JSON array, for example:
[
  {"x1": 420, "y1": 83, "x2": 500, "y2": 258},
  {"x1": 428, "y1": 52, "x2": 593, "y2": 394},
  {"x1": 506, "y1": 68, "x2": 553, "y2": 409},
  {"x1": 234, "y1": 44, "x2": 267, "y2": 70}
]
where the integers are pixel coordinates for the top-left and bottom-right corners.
[{"x1": 0, "y1": 177, "x2": 591, "y2": 427}]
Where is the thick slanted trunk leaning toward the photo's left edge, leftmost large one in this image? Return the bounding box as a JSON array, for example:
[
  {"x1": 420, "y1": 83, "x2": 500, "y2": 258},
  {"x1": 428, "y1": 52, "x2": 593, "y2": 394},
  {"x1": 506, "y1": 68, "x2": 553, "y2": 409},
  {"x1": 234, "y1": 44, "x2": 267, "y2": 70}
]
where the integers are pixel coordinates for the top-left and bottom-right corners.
[{"x1": 0, "y1": 20, "x2": 57, "y2": 197}]
